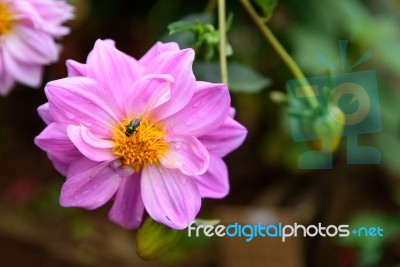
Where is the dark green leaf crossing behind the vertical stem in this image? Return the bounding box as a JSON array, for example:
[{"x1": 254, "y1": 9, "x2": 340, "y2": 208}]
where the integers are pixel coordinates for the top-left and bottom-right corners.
[{"x1": 193, "y1": 62, "x2": 271, "y2": 93}]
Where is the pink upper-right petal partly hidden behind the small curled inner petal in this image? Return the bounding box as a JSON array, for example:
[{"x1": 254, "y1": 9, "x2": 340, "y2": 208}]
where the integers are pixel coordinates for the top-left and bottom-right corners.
[{"x1": 145, "y1": 49, "x2": 196, "y2": 120}]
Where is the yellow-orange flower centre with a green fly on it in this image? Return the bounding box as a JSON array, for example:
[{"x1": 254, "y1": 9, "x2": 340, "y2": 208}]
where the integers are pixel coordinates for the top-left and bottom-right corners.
[{"x1": 113, "y1": 118, "x2": 168, "y2": 172}]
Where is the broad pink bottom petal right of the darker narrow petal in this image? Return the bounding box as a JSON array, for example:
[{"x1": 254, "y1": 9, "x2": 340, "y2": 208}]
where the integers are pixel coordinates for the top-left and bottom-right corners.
[{"x1": 141, "y1": 165, "x2": 201, "y2": 229}]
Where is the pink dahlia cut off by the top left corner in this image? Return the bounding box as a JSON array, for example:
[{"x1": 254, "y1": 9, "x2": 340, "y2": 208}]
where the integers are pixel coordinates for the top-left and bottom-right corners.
[{"x1": 0, "y1": 0, "x2": 73, "y2": 95}]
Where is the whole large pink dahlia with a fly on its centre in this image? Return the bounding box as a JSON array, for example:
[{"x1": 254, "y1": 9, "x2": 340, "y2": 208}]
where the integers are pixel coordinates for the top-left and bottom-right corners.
[{"x1": 35, "y1": 40, "x2": 247, "y2": 229}]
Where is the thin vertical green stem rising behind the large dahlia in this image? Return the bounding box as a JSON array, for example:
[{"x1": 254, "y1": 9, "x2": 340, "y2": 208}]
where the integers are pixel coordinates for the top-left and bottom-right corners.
[{"x1": 218, "y1": 0, "x2": 228, "y2": 86}]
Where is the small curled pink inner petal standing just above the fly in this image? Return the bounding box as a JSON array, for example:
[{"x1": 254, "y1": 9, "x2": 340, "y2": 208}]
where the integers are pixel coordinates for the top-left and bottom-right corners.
[{"x1": 125, "y1": 74, "x2": 174, "y2": 117}]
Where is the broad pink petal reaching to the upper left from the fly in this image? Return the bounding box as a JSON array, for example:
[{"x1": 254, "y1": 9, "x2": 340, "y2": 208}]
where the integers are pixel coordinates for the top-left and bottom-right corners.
[{"x1": 45, "y1": 77, "x2": 120, "y2": 137}]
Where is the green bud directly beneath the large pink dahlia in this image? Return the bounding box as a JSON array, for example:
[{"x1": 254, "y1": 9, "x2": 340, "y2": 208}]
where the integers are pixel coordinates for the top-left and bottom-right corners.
[{"x1": 136, "y1": 217, "x2": 183, "y2": 260}]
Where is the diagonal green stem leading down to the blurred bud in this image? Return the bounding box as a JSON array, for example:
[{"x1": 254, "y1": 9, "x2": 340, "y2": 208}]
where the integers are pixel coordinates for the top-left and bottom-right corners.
[{"x1": 240, "y1": 0, "x2": 318, "y2": 109}]
